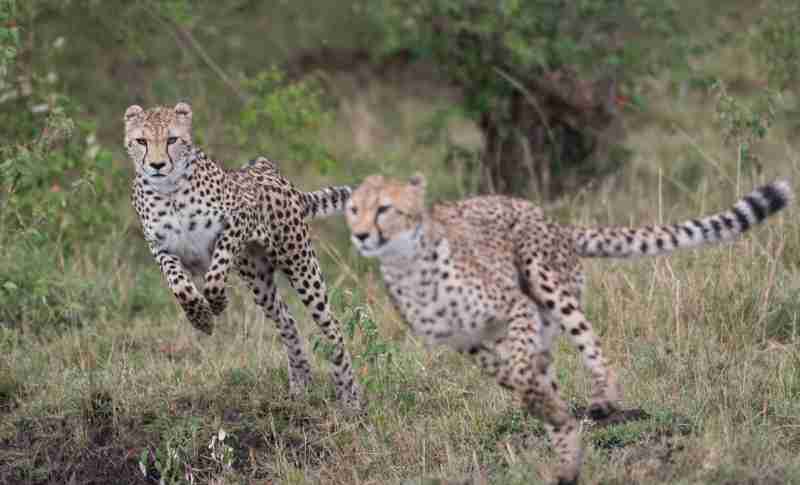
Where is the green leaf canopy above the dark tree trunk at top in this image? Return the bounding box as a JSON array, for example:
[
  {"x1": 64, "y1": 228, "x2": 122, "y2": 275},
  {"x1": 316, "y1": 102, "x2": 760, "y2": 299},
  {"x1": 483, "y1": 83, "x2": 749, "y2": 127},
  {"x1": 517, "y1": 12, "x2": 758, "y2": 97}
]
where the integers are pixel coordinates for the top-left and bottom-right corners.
[{"x1": 365, "y1": 0, "x2": 684, "y2": 120}]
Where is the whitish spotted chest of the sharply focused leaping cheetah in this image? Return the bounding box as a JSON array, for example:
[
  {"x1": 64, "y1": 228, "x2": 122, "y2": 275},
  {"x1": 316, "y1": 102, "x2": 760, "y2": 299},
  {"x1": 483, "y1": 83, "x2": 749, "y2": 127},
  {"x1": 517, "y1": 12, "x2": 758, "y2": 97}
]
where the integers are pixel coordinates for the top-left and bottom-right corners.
[{"x1": 153, "y1": 200, "x2": 225, "y2": 276}]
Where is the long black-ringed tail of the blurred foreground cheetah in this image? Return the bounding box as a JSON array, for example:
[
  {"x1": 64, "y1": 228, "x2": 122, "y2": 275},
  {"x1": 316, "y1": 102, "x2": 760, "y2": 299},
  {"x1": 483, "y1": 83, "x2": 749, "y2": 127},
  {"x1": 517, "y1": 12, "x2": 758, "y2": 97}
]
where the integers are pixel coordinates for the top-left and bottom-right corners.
[{"x1": 574, "y1": 180, "x2": 794, "y2": 258}]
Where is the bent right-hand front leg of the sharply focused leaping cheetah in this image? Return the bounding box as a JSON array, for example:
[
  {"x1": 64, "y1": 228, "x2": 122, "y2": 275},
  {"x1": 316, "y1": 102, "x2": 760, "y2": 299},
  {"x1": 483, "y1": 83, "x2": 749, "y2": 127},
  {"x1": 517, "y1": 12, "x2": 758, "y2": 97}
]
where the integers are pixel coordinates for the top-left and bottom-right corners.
[{"x1": 203, "y1": 218, "x2": 245, "y2": 315}]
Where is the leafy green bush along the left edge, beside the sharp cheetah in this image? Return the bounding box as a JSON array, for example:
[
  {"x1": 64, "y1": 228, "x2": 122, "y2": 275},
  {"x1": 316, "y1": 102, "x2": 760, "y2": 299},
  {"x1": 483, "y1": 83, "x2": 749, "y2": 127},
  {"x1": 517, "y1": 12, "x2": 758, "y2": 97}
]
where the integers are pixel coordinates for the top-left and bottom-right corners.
[{"x1": 0, "y1": 2, "x2": 145, "y2": 334}]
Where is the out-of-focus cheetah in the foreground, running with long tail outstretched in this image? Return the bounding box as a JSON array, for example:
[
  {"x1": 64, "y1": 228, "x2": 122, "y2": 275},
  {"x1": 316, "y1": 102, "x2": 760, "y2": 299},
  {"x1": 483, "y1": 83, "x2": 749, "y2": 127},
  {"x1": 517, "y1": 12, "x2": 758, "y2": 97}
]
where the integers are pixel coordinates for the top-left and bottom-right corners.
[{"x1": 345, "y1": 175, "x2": 792, "y2": 485}]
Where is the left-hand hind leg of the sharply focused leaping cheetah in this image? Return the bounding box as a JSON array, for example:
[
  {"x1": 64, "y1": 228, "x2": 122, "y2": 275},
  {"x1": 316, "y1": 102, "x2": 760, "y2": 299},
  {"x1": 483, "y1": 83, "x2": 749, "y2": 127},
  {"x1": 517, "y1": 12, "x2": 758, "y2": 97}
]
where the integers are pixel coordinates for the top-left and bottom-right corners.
[{"x1": 237, "y1": 251, "x2": 311, "y2": 398}]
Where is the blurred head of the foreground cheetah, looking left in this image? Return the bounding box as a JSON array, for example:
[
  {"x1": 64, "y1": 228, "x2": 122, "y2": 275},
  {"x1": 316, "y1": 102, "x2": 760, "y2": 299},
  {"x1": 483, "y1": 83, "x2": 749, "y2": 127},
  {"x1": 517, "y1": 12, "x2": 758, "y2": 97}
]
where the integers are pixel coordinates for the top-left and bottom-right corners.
[{"x1": 345, "y1": 174, "x2": 425, "y2": 257}]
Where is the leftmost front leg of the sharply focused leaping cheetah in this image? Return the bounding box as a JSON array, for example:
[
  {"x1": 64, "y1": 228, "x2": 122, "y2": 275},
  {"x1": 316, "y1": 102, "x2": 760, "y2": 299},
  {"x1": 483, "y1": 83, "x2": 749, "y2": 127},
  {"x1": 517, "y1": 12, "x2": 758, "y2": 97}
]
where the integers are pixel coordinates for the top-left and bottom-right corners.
[{"x1": 150, "y1": 245, "x2": 214, "y2": 335}]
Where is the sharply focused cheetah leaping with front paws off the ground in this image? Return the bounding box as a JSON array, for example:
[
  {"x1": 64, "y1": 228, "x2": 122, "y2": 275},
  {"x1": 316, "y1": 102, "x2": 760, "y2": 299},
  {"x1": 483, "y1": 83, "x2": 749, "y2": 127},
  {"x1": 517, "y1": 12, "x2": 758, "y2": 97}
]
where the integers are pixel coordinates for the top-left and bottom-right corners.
[{"x1": 124, "y1": 103, "x2": 361, "y2": 409}]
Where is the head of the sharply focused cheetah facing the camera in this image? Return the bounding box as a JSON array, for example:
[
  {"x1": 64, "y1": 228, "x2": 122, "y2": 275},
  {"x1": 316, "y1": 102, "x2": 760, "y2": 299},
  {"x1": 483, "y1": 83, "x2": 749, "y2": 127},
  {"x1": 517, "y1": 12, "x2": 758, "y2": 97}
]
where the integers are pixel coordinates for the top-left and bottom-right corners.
[{"x1": 125, "y1": 103, "x2": 192, "y2": 186}]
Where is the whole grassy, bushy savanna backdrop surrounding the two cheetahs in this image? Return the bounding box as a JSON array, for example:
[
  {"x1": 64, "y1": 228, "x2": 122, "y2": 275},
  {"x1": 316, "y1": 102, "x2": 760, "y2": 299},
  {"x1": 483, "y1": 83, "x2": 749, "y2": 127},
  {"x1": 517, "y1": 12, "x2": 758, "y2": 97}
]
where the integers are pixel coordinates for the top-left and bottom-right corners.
[{"x1": 0, "y1": 0, "x2": 800, "y2": 483}]
